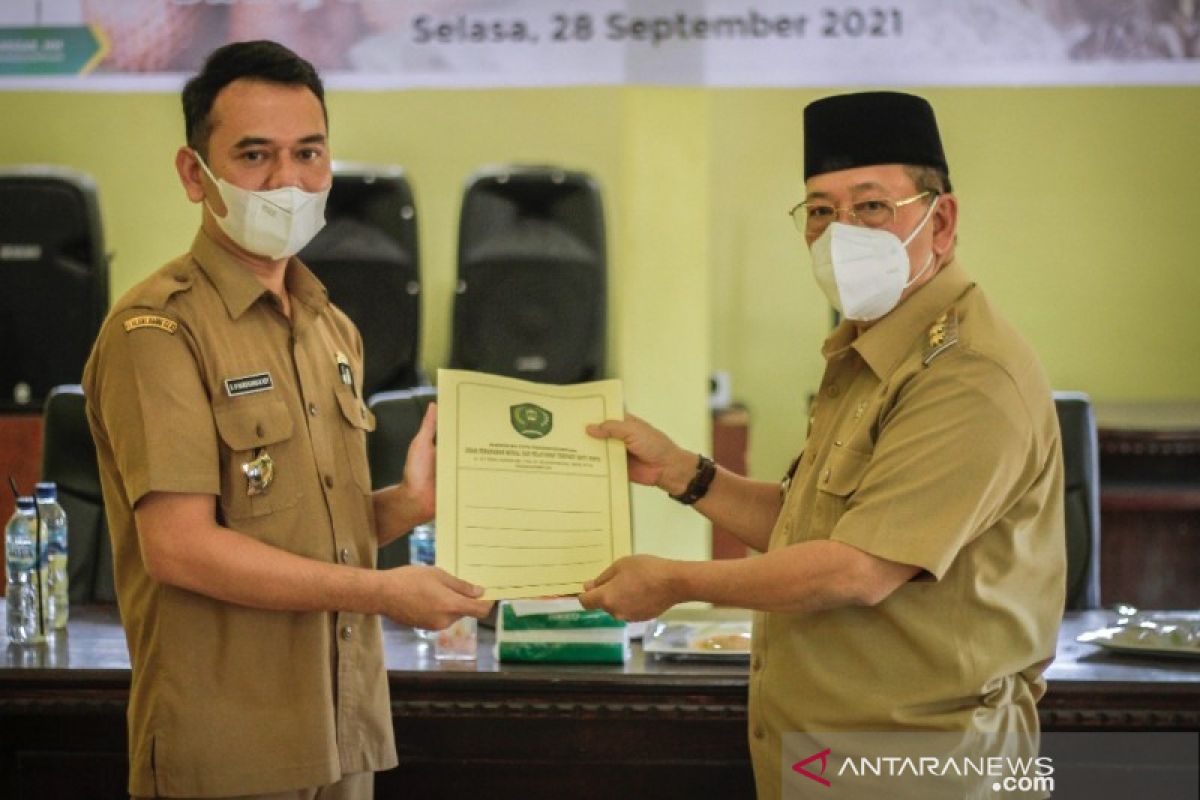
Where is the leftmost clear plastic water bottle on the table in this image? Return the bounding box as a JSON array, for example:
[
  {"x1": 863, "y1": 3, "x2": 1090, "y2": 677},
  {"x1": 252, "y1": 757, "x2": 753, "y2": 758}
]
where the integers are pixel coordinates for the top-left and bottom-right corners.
[{"x1": 5, "y1": 497, "x2": 50, "y2": 644}]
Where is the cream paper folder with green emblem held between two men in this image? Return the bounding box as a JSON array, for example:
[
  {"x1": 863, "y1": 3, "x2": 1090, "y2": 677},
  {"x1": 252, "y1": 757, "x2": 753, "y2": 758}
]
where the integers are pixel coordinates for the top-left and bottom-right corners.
[{"x1": 437, "y1": 369, "x2": 631, "y2": 600}]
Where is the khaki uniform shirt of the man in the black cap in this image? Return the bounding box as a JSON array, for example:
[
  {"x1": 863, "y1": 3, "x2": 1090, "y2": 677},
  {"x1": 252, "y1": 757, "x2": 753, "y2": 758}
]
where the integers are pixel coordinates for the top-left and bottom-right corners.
[{"x1": 749, "y1": 263, "x2": 1066, "y2": 798}]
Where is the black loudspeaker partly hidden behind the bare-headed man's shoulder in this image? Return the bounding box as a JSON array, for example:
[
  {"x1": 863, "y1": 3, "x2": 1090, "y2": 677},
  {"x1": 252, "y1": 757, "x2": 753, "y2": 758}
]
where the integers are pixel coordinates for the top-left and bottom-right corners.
[{"x1": 300, "y1": 164, "x2": 422, "y2": 397}]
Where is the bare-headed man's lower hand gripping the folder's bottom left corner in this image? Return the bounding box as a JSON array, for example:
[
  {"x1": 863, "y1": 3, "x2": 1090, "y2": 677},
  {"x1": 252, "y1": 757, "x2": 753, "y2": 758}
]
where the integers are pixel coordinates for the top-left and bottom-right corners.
[{"x1": 380, "y1": 565, "x2": 493, "y2": 630}]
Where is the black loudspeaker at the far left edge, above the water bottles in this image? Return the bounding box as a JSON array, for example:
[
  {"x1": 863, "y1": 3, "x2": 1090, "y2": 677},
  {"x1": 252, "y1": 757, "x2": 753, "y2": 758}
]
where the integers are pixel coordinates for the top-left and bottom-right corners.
[{"x1": 0, "y1": 166, "x2": 108, "y2": 413}]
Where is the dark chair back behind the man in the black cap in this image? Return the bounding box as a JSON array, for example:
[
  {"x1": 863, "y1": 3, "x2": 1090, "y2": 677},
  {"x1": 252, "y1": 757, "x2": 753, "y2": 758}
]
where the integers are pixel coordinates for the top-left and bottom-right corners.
[{"x1": 1054, "y1": 392, "x2": 1100, "y2": 609}]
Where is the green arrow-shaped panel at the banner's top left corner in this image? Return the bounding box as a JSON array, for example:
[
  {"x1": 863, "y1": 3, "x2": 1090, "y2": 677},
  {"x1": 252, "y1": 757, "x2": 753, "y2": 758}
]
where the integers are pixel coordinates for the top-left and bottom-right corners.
[{"x1": 0, "y1": 25, "x2": 108, "y2": 76}]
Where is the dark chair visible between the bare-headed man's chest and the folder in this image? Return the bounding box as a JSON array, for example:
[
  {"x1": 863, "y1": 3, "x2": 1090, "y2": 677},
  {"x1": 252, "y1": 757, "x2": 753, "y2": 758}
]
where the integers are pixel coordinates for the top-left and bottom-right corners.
[{"x1": 367, "y1": 386, "x2": 437, "y2": 569}]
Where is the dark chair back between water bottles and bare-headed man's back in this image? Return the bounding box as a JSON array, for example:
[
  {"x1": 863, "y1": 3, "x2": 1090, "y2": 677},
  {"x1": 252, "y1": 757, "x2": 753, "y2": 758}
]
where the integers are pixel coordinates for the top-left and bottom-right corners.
[{"x1": 42, "y1": 384, "x2": 116, "y2": 603}]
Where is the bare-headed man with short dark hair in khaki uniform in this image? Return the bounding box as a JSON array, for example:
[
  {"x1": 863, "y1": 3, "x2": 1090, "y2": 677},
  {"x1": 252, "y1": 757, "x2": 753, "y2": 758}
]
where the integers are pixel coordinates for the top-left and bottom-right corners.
[{"x1": 84, "y1": 42, "x2": 491, "y2": 800}]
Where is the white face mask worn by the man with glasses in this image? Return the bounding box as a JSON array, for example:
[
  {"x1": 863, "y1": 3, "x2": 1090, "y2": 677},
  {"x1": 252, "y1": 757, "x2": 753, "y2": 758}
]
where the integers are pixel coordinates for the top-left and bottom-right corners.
[{"x1": 810, "y1": 196, "x2": 938, "y2": 323}]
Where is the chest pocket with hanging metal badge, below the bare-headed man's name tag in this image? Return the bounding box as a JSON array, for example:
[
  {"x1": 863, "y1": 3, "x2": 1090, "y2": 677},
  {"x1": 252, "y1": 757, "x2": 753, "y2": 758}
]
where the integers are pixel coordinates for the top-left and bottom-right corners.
[{"x1": 212, "y1": 398, "x2": 300, "y2": 521}]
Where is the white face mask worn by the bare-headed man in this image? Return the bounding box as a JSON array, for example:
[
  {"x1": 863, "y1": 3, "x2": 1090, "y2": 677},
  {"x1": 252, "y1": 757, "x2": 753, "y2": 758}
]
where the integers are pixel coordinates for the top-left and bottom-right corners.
[{"x1": 196, "y1": 154, "x2": 329, "y2": 259}]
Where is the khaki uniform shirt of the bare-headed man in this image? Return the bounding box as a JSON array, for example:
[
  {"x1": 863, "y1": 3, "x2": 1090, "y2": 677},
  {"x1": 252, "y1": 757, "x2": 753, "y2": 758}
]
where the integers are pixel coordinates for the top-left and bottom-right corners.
[{"x1": 84, "y1": 231, "x2": 396, "y2": 796}]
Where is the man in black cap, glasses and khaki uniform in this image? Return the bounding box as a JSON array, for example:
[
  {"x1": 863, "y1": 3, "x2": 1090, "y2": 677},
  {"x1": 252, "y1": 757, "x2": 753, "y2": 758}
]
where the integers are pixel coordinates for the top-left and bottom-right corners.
[{"x1": 582, "y1": 92, "x2": 1066, "y2": 798}]
